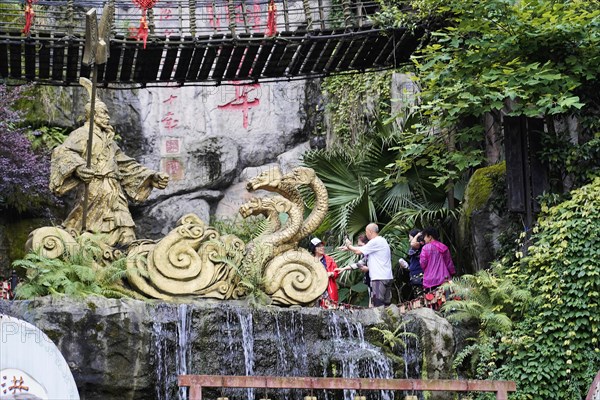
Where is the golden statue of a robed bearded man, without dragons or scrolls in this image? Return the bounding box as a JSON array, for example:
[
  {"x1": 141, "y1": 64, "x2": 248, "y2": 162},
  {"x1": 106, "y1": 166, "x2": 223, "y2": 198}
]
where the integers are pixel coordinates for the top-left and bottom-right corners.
[{"x1": 50, "y1": 79, "x2": 169, "y2": 247}]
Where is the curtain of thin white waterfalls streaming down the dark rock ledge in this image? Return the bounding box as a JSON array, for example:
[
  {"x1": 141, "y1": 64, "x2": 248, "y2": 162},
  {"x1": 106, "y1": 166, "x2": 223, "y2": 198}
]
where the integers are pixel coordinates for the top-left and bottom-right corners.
[{"x1": 153, "y1": 304, "x2": 412, "y2": 400}]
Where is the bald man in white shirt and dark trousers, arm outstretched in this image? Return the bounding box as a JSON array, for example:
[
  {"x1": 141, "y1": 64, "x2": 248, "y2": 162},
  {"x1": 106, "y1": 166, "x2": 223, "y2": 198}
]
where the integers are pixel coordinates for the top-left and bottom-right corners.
[{"x1": 342, "y1": 223, "x2": 394, "y2": 307}]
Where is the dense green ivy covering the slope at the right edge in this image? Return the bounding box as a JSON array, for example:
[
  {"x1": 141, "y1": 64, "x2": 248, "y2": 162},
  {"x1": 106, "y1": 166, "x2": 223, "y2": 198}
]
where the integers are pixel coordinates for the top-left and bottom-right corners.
[{"x1": 500, "y1": 178, "x2": 600, "y2": 400}]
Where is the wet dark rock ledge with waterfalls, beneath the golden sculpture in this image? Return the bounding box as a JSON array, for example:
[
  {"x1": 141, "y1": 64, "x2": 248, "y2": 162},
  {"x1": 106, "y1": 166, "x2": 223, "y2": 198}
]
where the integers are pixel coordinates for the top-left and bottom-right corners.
[{"x1": 0, "y1": 297, "x2": 454, "y2": 400}]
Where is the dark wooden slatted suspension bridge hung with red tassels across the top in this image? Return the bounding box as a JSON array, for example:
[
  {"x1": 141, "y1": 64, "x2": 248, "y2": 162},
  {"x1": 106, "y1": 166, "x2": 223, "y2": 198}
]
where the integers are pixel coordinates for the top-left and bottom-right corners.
[{"x1": 0, "y1": 0, "x2": 424, "y2": 88}]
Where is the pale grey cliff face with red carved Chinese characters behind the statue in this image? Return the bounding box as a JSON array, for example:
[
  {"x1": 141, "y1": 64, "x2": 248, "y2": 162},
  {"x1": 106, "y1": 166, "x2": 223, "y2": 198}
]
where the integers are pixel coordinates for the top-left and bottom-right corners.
[{"x1": 15, "y1": 80, "x2": 320, "y2": 248}]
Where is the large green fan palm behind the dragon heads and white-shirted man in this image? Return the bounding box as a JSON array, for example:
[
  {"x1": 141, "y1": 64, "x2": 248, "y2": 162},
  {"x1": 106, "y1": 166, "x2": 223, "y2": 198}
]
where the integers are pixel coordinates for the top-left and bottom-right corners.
[{"x1": 303, "y1": 119, "x2": 466, "y2": 304}]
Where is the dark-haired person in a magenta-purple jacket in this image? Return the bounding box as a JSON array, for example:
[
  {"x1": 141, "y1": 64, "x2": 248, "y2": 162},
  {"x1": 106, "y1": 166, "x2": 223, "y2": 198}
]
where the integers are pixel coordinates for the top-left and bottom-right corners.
[{"x1": 419, "y1": 228, "x2": 456, "y2": 291}]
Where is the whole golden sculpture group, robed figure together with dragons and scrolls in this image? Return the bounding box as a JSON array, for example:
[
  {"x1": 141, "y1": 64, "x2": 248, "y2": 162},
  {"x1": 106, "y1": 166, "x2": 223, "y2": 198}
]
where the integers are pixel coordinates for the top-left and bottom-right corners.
[{"x1": 28, "y1": 79, "x2": 328, "y2": 305}]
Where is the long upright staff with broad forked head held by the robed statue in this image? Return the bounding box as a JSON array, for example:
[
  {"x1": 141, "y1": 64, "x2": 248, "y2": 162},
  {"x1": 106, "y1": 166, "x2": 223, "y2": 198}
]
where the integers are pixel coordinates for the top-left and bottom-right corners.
[{"x1": 79, "y1": 4, "x2": 114, "y2": 231}]
